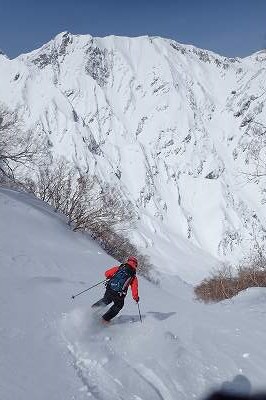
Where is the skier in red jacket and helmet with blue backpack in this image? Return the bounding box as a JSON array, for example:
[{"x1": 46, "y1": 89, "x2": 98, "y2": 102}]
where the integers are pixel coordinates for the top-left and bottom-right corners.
[{"x1": 92, "y1": 256, "x2": 139, "y2": 324}]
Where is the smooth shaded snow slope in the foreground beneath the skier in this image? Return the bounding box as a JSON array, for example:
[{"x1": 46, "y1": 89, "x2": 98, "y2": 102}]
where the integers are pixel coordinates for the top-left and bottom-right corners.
[{"x1": 0, "y1": 189, "x2": 266, "y2": 400}]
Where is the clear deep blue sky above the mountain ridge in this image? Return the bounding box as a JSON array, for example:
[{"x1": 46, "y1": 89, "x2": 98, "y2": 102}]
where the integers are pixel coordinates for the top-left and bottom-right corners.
[{"x1": 0, "y1": 0, "x2": 266, "y2": 58}]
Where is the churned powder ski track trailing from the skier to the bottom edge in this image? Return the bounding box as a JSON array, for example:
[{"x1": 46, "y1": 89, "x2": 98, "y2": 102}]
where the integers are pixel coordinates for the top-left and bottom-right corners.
[{"x1": 60, "y1": 311, "x2": 175, "y2": 400}]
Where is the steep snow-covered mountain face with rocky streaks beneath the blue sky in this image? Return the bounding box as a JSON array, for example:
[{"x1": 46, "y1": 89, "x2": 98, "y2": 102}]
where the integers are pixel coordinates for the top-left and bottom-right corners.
[{"x1": 0, "y1": 33, "x2": 266, "y2": 280}]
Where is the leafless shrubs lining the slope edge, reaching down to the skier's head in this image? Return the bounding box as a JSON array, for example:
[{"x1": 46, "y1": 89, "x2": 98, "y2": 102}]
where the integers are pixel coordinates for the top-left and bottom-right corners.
[{"x1": 24, "y1": 158, "x2": 155, "y2": 282}]
